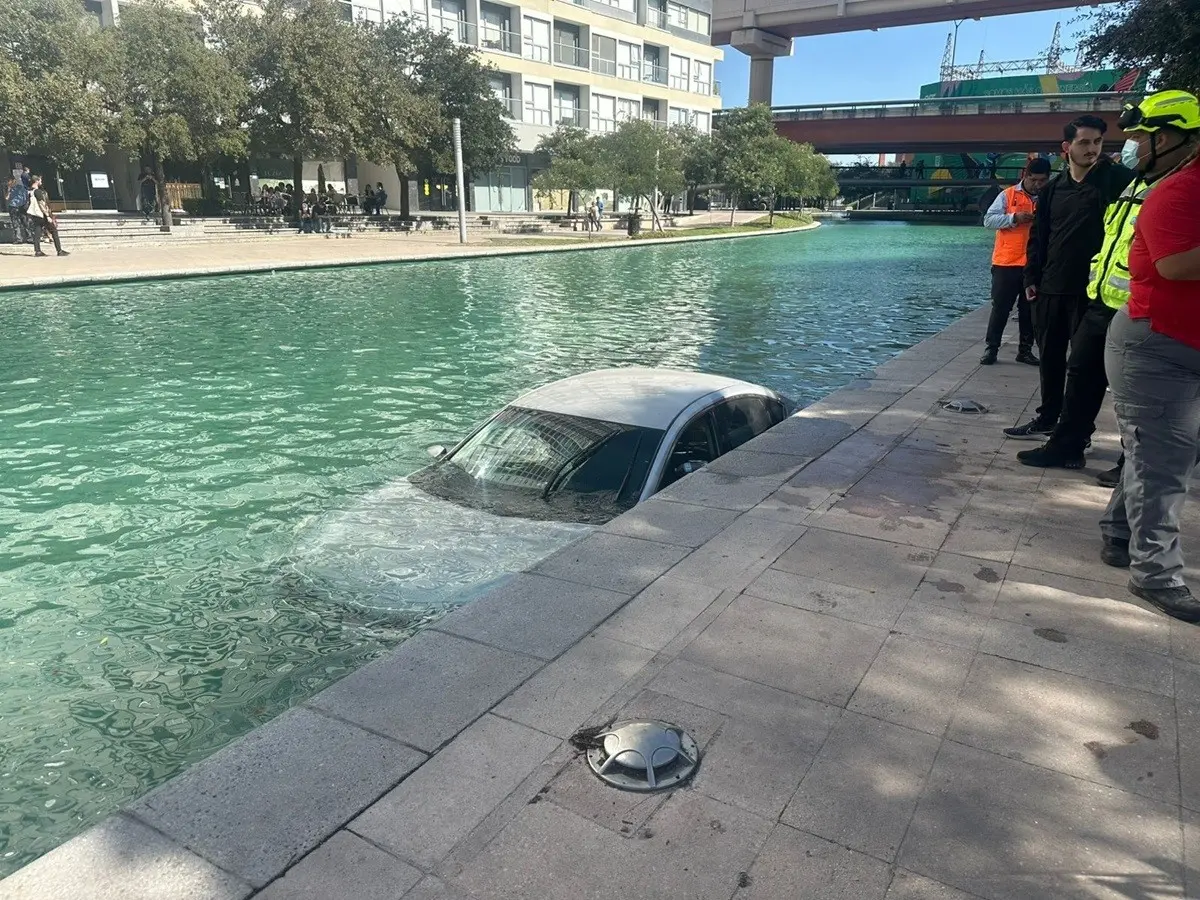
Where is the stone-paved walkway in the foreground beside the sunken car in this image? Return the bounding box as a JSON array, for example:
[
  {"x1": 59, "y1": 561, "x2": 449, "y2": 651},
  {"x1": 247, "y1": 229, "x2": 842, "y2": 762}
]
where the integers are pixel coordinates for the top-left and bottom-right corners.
[{"x1": 0, "y1": 304, "x2": 1200, "y2": 900}]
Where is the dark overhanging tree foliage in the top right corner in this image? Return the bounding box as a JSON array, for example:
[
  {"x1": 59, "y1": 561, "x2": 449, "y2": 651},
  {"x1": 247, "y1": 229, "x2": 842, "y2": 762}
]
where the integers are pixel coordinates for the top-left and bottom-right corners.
[{"x1": 1081, "y1": 0, "x2": 1200, "y2": 94}]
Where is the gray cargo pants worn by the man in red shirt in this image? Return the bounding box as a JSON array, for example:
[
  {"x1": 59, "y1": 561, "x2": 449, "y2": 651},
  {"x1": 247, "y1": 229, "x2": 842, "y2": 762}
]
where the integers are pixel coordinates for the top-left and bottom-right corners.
[{"x1": 1100, "y1": 310, "x2": 1200, "y2": 588}]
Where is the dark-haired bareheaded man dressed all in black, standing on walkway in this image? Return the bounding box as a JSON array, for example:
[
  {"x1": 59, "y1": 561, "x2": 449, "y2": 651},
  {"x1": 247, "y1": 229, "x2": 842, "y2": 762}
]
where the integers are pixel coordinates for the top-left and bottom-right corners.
[{"x1": 1004, "y1": 115, "x2": 1134, "y2": 440}]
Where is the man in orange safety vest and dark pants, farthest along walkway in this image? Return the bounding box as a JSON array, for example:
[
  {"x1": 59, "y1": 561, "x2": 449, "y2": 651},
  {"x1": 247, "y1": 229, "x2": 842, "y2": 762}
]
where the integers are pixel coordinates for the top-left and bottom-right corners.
[{"x1": 979, "y1": 158, "x2": 1050, "y2": 366}]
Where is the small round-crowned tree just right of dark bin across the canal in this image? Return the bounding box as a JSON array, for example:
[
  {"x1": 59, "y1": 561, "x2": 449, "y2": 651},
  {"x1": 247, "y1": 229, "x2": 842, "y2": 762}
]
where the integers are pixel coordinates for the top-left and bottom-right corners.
[{"x1": 599, "y1": 119, "x2": 685, "y2": 230}]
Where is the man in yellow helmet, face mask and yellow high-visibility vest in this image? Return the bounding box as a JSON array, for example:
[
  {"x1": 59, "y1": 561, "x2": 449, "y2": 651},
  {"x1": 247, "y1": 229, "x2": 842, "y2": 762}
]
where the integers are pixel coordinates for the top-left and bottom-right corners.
[{"x1": 1016, "y1": 91, "x2": 1200, "y2": 469}]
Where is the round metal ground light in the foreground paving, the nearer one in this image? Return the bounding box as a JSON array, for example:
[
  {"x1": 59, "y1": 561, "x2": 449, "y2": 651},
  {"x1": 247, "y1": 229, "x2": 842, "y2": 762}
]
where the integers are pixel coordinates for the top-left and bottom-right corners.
[{"x1": 587, "y1": 720, "x2": 700, "y2": 792}]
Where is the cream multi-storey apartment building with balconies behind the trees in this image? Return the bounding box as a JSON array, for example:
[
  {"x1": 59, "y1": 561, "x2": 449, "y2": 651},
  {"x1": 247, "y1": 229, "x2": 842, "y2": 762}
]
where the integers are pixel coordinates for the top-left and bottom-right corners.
[{"x1": 340, "y1": 0, "x2": 722, "y2": 212}]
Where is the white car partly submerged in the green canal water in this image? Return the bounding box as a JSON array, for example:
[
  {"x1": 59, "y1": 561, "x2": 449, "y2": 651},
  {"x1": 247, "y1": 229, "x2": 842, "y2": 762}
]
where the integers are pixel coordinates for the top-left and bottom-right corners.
[{"x1": 289, "y1": 368, "x2": 790, "y2": 614}]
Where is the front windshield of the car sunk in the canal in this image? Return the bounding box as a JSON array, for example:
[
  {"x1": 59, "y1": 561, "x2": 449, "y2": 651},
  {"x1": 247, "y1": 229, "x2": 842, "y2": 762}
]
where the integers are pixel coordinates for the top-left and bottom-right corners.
[{"x1": 412, "y1": 407, "x2": 662, "y2": 523}]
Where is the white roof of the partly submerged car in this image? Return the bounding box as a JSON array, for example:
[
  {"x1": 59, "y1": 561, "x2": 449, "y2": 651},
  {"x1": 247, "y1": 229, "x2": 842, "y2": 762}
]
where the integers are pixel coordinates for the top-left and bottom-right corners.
[{"x1": 511, "y1": 367, "x2": 776, "y2": 431}]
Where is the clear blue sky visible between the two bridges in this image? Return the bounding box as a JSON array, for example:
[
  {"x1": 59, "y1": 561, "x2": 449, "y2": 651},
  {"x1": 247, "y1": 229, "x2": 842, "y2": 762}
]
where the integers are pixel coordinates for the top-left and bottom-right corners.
[{"x1": 715, "y1": 8, "x2": 1081, "y2": 107}]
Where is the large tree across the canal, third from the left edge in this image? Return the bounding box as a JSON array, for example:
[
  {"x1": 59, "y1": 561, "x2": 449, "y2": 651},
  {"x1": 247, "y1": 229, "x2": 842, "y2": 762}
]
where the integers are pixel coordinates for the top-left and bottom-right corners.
[{"x1": 205, "y1": 0, "x2": 364, "y2": 209}]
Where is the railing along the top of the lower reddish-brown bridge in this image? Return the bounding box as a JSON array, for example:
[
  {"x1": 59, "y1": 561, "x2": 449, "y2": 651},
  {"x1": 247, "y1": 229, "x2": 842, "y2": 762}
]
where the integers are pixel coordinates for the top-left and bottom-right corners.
[{"x1": 772, "y1": 91, "x2": 1142, "y2": 121}]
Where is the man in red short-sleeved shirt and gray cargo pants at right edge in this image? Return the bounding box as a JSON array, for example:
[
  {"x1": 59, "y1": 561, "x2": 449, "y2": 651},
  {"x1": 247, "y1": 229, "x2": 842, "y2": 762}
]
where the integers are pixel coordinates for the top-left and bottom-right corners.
[{"x1": 1100, "y1": 95, "x2": 1200, "y2": 623}]
